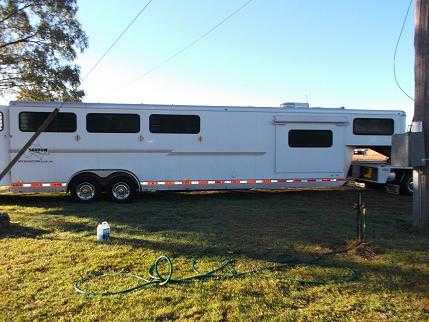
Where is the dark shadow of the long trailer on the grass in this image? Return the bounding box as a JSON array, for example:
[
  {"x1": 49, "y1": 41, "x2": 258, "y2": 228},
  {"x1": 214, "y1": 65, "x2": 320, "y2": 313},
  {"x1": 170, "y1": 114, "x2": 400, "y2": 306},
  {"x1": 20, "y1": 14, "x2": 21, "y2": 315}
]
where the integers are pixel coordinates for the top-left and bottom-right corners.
[{"x1": 0, "y1": 190, "x2": 422, "y2": 257}]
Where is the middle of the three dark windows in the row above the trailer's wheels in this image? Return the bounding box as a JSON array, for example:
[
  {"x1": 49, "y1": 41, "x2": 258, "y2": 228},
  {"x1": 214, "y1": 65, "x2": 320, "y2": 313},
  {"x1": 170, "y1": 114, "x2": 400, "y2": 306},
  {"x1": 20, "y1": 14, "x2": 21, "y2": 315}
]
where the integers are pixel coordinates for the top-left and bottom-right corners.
[{"x1": 86, "y1": 113, "x2": 140, "y2": 133}]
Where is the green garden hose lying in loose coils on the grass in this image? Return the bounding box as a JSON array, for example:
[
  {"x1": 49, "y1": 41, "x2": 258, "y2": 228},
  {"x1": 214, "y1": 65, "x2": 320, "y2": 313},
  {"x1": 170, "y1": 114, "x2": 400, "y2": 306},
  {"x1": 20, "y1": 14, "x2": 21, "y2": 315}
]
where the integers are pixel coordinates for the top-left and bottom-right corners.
[{"x1": 74, "y1": 244, "x2": 360, "y2": 296}]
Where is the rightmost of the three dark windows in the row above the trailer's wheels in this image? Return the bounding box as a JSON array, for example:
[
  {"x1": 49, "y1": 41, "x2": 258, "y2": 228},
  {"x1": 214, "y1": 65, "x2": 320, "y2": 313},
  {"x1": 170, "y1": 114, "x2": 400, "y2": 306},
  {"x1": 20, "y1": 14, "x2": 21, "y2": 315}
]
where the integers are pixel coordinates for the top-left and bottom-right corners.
[{"x1": 149, "y1": 114, "x2": 201, "y2": 134}]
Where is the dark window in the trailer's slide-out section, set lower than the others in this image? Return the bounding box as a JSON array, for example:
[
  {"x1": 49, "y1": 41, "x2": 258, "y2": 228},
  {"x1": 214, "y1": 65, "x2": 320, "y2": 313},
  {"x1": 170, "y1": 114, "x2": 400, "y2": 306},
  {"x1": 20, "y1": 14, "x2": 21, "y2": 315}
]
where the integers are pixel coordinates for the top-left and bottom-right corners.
[{"x1": 289, "y1": 130, "x2": 332, "y2": 148}]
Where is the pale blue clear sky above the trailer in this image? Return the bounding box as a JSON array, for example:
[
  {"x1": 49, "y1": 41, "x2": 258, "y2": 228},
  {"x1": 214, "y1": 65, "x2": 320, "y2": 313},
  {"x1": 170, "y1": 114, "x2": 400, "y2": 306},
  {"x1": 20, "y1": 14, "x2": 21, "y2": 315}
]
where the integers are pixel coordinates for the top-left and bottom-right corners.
[{"x1": 3, "y1": 0, "x2": 414, "y2": 123}]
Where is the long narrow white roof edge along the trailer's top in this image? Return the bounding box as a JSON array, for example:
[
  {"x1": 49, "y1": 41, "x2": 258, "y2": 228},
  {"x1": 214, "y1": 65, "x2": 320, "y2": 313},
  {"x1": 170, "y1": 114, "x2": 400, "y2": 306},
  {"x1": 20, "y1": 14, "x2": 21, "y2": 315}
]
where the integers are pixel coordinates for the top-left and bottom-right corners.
[{"x1": 9, "y1": 101, "x2": 405, "y2": 115}]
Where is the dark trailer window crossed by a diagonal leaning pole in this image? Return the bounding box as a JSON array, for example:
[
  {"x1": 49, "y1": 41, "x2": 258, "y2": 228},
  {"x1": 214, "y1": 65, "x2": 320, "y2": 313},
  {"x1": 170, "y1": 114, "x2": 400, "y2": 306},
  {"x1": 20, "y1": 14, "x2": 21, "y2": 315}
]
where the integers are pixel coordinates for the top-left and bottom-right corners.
[{"x1": 19, "y1": 112, "x2": 77, "y2": 132}]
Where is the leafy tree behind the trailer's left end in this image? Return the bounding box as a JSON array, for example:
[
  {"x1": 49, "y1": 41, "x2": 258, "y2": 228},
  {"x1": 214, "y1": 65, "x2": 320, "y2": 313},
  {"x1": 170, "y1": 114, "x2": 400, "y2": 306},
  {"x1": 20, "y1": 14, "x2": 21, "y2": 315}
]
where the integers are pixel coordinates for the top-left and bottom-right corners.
[{"x1": 0, "y1": 0, "x2": 88, "y2": 101}]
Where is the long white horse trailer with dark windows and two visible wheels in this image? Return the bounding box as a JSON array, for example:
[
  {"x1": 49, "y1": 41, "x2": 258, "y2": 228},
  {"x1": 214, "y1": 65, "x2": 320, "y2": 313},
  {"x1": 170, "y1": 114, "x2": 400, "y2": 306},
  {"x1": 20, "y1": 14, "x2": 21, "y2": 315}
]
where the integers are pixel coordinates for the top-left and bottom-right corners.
[{"x1": 0, "y1": 102, "x2": 405, "y2": 201}]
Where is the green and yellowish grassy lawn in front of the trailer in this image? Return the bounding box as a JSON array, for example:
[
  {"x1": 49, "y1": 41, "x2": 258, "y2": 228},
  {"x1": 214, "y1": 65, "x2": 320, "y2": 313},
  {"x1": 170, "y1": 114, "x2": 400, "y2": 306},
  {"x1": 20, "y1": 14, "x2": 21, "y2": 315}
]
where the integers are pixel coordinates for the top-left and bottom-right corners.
[{"x1": 0, "y1": 188, "x2": 429, "y2": 321}]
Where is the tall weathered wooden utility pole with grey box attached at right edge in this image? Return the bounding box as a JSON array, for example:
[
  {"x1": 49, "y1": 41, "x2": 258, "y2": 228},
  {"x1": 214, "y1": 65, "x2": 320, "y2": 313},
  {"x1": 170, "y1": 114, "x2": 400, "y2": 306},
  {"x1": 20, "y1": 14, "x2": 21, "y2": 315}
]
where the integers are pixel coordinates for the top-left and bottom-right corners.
[{"x1": 412, "y1": 0, "x2": 429, "y2": 228}]
